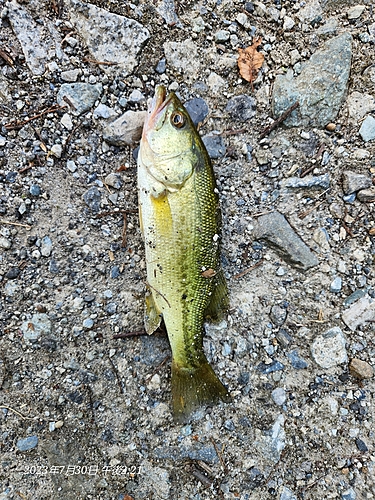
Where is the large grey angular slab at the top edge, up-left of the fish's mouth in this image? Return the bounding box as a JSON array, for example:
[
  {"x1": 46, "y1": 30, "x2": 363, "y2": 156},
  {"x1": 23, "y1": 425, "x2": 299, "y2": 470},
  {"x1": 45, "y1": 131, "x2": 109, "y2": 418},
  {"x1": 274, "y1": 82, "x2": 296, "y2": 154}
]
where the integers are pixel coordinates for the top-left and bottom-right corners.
[{"x1": 65, "y1": 0, "x2": 150, "y2": 76}]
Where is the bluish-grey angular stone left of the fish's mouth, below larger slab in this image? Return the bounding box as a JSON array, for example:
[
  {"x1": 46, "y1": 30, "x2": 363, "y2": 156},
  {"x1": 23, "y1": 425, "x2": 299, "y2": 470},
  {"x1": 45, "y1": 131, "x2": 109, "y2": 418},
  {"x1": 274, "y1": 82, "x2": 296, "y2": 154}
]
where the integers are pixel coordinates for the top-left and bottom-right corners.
[{"x1": 57, "y1": 82, "x2": 102, "y2": 116}]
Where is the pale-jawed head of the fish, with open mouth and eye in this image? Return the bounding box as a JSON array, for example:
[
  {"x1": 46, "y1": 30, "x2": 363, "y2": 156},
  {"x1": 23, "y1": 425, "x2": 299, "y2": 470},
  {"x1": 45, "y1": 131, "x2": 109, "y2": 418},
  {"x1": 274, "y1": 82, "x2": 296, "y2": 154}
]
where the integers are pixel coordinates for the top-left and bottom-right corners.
[{"x1": 139, "y1": 85, "x2": 202, "y2": 192}]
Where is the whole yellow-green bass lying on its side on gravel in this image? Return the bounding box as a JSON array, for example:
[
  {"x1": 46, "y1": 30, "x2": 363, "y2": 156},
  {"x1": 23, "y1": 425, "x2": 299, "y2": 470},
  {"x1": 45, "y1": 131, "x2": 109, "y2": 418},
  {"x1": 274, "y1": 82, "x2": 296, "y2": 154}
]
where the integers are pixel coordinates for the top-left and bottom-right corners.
[{"x1": 137, "y1": 85, "x2": 229, "y2": 423}]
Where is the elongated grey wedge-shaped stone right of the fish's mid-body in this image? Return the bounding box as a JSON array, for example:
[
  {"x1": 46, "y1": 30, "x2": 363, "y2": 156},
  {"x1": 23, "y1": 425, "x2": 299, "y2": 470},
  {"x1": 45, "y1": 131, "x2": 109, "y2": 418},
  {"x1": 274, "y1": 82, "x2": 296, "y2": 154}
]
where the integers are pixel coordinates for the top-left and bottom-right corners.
[{"x1": 253, "y1": 211, "x2": 319, "y2": 271}]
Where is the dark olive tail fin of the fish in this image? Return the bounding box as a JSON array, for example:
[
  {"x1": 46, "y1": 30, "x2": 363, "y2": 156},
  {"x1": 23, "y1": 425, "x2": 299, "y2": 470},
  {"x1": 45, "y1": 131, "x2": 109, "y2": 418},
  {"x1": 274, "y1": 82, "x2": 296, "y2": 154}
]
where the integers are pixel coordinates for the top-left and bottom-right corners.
[{"x1": 171, "y1": 360, "x2": 229, "y2": 423}]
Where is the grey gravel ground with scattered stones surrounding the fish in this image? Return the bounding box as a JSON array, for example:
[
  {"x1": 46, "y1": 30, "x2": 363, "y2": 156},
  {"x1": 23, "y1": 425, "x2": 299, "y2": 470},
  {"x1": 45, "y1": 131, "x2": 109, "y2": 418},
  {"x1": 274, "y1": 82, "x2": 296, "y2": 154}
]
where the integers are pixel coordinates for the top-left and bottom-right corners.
[{"x1": 0, "y1": 0, "x2": 375, "y2": 500}]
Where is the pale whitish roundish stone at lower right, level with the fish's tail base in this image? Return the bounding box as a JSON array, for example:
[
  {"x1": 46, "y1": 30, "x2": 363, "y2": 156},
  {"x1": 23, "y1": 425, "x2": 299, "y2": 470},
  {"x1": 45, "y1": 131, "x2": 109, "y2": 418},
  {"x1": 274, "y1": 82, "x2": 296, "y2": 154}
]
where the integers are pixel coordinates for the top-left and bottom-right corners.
[{"x1": 311, "y1": 326, "x2": 348, "y2": 368}]
